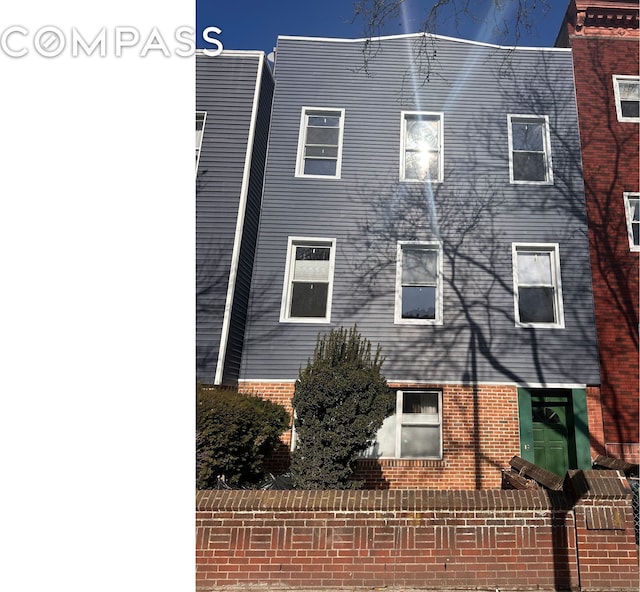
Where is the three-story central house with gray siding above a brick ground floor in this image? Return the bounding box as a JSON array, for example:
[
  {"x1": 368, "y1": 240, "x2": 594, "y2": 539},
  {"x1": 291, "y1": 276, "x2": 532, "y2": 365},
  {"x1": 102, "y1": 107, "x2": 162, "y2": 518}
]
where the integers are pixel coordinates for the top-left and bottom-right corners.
[{"x1": 239, "y1": 35, "x2": 600, "y2": 489}]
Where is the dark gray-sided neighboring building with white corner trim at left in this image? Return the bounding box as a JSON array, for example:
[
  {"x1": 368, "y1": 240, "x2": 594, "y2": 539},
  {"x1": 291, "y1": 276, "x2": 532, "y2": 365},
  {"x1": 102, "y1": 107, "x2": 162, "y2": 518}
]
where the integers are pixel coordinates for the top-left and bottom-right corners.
[{"x1": 196, "y1": 51, "x2": 274, "y2": 384}]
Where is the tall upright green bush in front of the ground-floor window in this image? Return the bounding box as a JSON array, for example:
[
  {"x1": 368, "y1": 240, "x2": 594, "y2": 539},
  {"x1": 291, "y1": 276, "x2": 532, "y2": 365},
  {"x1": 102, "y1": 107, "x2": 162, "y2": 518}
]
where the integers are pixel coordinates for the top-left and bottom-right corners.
[{"x1": 291, "y1": 327, "x2": 395, "y2": 489}]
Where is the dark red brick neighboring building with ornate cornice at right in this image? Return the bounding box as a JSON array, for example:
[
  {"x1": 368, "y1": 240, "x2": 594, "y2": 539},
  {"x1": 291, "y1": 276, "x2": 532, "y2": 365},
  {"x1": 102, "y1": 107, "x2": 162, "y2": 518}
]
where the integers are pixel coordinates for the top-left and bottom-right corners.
[{"x1": 558, "y1": 0, "x2": 640, "y2": 463}]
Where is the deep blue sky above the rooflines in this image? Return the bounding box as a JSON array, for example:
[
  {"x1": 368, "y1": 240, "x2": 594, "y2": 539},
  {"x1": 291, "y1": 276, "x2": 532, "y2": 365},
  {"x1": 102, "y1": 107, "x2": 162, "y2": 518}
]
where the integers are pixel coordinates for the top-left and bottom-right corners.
[{"x1": 196, "y1": 0, "x2": 569, "y2": 53}]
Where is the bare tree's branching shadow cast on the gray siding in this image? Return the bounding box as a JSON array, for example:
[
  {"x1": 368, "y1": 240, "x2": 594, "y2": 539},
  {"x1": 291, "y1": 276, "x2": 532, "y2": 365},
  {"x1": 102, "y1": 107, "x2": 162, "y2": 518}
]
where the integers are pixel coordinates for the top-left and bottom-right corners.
[{"x1": 342, "y1": 51, "x2": 597, "y2": 488}]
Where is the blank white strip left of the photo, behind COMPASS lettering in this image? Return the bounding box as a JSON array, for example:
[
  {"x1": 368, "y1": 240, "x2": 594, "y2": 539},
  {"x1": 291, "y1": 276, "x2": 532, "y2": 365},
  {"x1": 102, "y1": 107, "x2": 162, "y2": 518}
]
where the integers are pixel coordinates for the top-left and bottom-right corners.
[{"x1": 0, "y1": 0, "x2": 195, "y2": 592}]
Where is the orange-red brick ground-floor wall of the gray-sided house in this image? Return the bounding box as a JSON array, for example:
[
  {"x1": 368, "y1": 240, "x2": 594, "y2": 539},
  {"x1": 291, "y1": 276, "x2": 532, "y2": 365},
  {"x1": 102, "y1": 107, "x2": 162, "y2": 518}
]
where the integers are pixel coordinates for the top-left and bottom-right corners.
[{"x1": 239, "y1": 381, "x2": 520, "y2": 489}]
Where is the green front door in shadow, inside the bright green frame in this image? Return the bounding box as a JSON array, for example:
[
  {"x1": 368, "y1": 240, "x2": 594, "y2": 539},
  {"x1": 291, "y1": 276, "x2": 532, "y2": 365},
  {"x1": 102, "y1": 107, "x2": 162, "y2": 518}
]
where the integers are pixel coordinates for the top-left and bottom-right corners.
[{"x1": 531, "y1": 396, "x2": 574, "y2": 476}]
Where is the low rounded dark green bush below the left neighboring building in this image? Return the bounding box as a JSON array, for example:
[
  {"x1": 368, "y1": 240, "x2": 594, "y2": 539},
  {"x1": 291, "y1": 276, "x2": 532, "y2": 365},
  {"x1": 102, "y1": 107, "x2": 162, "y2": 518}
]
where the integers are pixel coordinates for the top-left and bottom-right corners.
[{"x1": 196, "y1": 385, "x2": 289, "y2": 489}]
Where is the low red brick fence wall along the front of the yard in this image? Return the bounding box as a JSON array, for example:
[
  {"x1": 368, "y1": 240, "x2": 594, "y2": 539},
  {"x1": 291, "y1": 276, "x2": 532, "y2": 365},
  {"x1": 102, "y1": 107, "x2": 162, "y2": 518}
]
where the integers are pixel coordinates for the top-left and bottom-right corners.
[{"x1": 196, "y1": 471, "x2": 639, "y2": 592}]
